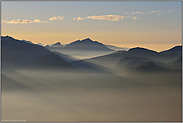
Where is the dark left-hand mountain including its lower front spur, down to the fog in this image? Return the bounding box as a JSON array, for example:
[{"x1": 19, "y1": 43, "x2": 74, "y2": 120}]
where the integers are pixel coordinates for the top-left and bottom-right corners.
[{"x1": 1, "y1": 36, "x2": 74, "y2": 69}]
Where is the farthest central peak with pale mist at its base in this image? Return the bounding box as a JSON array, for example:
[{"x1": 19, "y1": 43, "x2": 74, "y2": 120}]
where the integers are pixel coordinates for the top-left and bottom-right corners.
[{"x1": 45, "y1": 38, "x2": 114, "y2": 59}]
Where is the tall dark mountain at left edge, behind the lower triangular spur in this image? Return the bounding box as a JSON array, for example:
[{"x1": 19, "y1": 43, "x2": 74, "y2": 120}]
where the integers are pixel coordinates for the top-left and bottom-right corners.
[{"x1": 1, "y1": 36, "x2": 51, "y2": 68}]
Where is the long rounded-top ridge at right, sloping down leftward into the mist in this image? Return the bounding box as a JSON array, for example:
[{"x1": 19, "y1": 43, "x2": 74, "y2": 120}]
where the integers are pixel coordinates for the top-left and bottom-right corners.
[{"x1": 85, "y1": 47, "x2": 182, "y2": 68}]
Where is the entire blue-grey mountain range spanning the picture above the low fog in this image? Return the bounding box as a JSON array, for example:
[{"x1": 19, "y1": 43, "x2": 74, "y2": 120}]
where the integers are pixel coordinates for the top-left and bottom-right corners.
[{"x1": 1, "y1": 36, "x2": 182, "y2": 73}]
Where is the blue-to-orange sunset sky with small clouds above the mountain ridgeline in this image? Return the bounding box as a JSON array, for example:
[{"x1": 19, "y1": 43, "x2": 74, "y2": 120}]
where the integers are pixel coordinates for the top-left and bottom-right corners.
[{"x1": 1, "y1": 1, "x2": 182, "y2": 51}]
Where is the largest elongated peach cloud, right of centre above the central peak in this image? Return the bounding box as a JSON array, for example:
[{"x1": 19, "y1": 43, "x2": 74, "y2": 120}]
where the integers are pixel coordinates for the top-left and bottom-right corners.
[{"x1": 86, "y1": 15, "x2": 124, "y2": 21}]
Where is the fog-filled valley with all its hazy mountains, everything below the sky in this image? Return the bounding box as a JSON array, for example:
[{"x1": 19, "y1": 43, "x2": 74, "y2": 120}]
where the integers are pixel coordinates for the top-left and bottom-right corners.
[{"x1": 1, "y1": 36, "x2": 182, "y2": 122}]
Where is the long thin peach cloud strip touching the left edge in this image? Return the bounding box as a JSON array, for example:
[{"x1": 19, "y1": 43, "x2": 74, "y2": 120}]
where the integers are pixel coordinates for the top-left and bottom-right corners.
[{"x1": 1, "y1": 19, "x2": 48, "y2": 24}]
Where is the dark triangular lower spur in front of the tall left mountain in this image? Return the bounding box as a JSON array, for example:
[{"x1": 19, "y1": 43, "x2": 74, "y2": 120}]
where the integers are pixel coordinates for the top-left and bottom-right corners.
[{"x1": 29, "y1": 53, "x2": 75, "y2": 70}]
